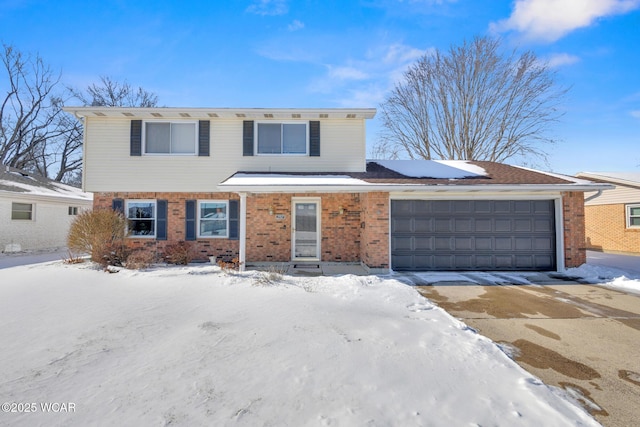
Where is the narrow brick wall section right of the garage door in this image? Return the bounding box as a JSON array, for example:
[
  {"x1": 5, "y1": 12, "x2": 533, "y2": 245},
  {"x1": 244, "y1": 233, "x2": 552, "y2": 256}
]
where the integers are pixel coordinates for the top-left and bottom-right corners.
[{"x1": 562, "y1": 192, "x2": 587, "y2": 268}]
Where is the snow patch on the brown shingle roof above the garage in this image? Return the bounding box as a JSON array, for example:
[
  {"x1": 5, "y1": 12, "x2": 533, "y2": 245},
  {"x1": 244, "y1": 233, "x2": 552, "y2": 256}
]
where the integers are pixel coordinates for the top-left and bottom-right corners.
[{"x1": 369, "y1": 160, "x2": 487, "y2": 179}]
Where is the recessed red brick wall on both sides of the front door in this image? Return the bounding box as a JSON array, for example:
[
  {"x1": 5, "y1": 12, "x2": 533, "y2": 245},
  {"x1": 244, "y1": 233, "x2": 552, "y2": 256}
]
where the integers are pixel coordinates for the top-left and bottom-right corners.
[{"x1": 246, "y1": 193, "x2": 361, "y2": 262}]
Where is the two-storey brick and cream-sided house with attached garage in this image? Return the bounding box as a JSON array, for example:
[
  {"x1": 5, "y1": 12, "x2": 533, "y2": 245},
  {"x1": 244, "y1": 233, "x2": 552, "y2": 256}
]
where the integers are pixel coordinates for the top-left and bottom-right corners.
[{"x1": 65, "y1": 107, "x2": 606, "y2": 271}]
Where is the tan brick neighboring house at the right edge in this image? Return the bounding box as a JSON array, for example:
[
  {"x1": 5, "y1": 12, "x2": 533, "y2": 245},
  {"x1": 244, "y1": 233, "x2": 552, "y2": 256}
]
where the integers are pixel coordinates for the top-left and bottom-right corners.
[{"x1": 577, "y1": 172, "x2": 640, "y2": 254}]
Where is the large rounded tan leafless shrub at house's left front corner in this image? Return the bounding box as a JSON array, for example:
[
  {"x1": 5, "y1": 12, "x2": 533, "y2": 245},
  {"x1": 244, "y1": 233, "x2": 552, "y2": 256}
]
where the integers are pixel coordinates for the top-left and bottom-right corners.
[{"x1": 67, "y1": 209, "x2": 127, "y2": 266}]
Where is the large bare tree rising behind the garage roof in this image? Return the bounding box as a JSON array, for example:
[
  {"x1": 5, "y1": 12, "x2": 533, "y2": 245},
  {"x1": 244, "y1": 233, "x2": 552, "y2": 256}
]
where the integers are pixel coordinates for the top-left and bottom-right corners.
[{"x1": 381, "y1": 37, "x2": 568, "y2": 166}]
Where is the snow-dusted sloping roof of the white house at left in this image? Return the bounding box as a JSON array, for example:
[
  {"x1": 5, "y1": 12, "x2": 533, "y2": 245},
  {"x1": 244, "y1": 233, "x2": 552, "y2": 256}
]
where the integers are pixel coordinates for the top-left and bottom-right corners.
[{"x1": 0, "y1": 166, "x2": 93, "y2": 202}]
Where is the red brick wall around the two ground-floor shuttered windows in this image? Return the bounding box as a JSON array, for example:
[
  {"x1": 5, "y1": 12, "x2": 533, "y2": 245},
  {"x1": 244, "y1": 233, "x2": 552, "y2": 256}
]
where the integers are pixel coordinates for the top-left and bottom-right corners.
[{"x1": 93, "y1": 192, "x2": 239, "y2": 261}]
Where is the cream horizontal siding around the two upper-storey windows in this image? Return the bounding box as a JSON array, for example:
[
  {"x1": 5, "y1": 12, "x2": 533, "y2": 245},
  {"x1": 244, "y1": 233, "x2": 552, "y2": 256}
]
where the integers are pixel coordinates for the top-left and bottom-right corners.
[{"x1": 84, "y1": 117, "x2": 366, "y2": 192}]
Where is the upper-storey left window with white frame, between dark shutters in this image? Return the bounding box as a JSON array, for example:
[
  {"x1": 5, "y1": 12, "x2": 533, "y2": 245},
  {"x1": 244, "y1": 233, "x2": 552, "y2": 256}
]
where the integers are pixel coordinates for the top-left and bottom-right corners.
[{"x1": 144, "y1": 121, "x2": 198, "y2": 155}]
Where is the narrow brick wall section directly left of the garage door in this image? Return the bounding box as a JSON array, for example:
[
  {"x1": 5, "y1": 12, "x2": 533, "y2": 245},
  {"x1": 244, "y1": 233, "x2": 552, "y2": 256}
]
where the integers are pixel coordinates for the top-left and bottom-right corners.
[{"x1": 360, "y1": 192, "x2": 390, "y2": 269}]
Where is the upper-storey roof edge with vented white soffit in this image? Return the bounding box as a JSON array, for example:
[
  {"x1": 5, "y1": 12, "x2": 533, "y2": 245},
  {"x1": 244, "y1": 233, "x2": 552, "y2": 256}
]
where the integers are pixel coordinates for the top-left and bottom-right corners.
[{"x1": 63, "y1": 106, "x2": 376, "y2": 120}]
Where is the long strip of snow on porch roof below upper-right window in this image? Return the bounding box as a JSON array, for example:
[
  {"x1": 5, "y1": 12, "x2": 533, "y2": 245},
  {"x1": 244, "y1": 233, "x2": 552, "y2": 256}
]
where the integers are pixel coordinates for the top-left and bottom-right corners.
[{"x1": 223, "y1": 173, "x2": 369, "y2": 186}]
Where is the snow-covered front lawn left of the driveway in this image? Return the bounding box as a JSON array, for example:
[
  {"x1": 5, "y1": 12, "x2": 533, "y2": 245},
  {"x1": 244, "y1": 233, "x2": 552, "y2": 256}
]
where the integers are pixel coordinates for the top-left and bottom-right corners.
[{"x1": 0, "y1": 262, "x2": 597, "y2": 426}]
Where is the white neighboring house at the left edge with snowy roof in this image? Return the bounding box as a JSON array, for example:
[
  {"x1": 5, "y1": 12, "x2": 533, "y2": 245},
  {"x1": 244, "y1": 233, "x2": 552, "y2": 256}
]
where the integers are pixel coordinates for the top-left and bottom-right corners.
[{"x1": 0, "y1": 166, "x2": 93, "y2": 252}]
